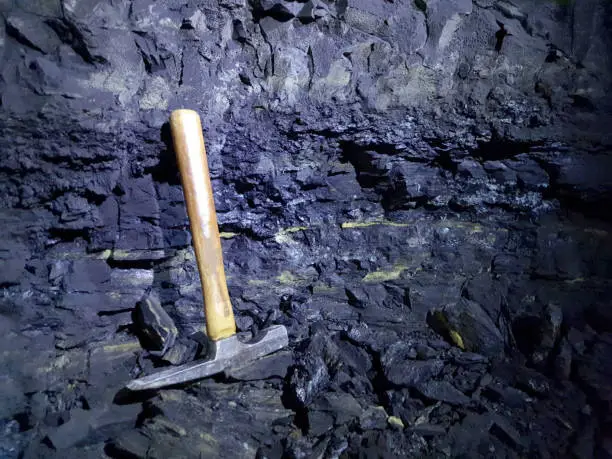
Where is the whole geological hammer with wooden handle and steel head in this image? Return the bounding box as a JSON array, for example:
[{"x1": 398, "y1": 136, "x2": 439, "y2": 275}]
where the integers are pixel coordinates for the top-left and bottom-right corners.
[{"x1": 127, "y1": 109, "x2": 289, "y2": 390}]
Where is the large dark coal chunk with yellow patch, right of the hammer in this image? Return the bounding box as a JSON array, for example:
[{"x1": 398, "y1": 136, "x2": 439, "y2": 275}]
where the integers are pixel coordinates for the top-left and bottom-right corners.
[{"x1": 427, "y1": 298, "x2": 505, "y2": 357}]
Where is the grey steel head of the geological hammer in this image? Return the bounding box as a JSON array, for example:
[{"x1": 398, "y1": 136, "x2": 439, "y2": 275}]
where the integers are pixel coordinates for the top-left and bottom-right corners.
[{"x1": 126, "y1": 325, "x2": 289, "y2": 391}]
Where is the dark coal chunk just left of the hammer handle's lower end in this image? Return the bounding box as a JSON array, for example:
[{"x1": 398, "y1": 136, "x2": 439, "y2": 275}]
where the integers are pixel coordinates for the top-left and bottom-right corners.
[{"x1": 132, "y1": 293, "x2": 178, "y2": 356}]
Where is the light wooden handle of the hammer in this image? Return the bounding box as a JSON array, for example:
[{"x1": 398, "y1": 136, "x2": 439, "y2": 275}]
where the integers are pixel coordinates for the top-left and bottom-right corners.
[{"x1": 170, "y1": 110, "x2": 236, "y2": 341}]
